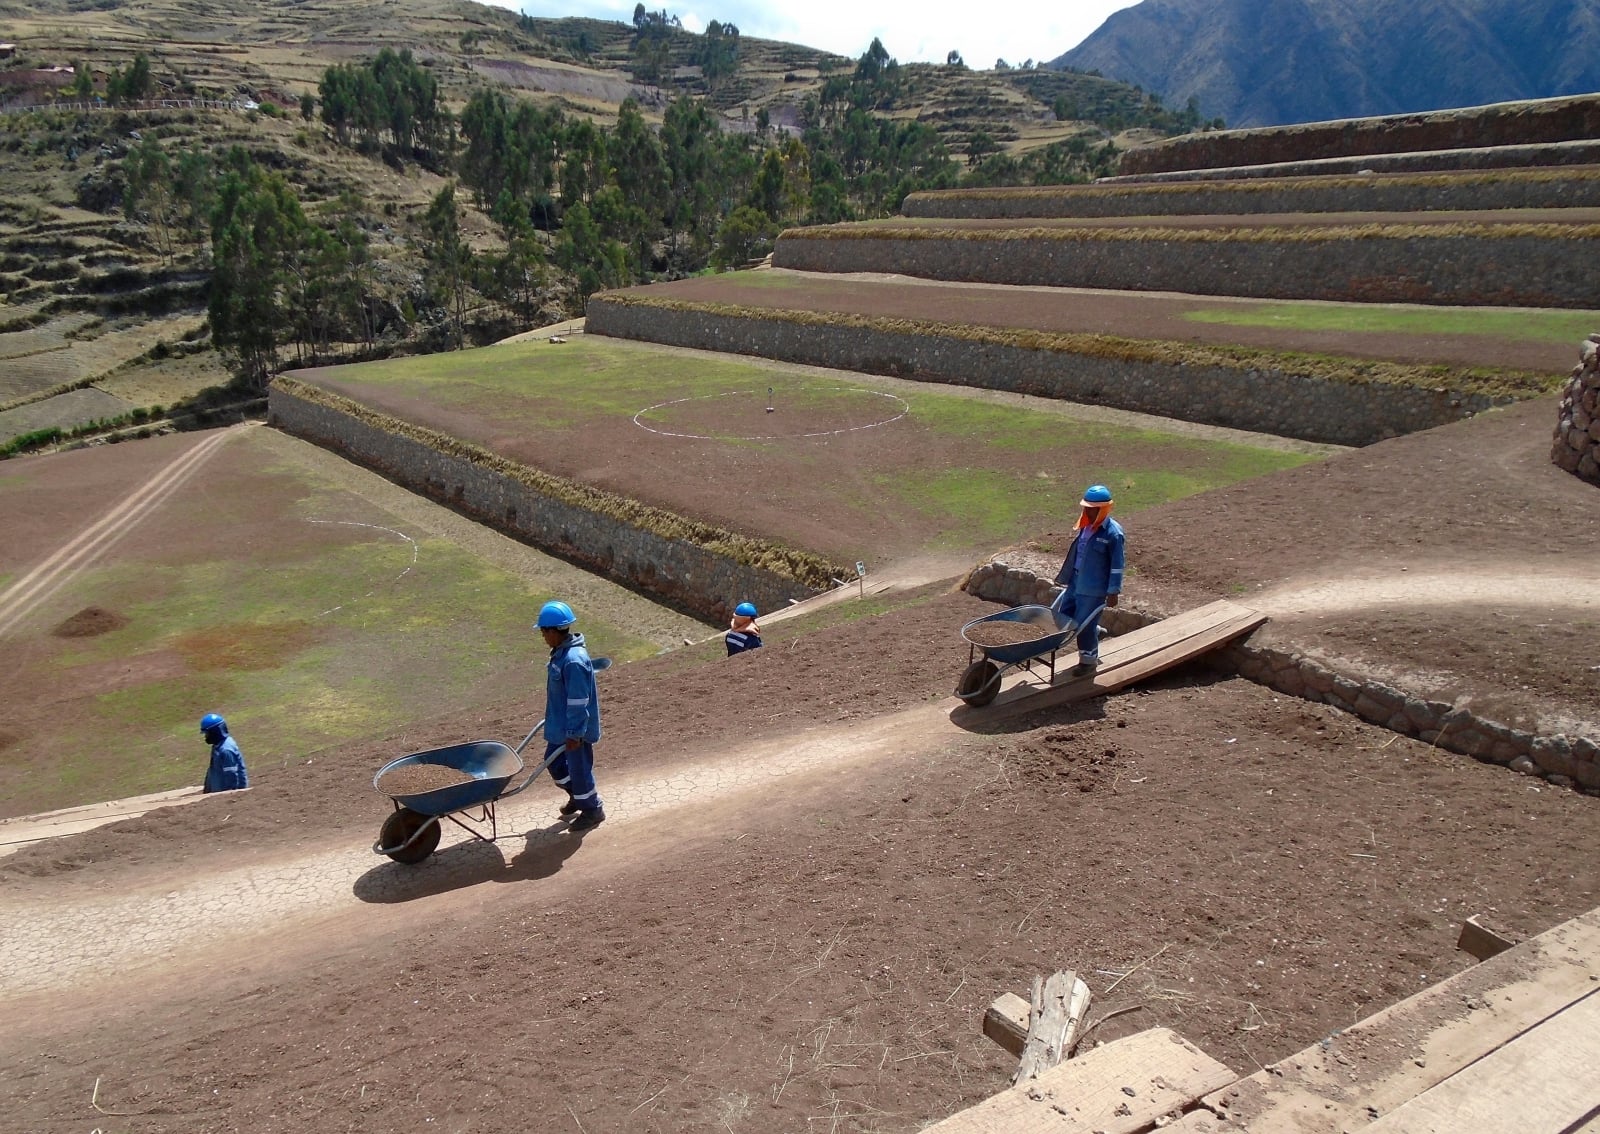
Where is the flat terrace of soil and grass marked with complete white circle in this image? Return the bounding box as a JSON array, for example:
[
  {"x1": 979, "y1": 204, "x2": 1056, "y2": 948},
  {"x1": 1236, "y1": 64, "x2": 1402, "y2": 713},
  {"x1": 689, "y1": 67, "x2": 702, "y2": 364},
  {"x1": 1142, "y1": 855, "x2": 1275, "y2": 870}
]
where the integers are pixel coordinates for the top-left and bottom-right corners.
[{"x1": 296, "y1": 336, "x2": 1325, "y2": 566}]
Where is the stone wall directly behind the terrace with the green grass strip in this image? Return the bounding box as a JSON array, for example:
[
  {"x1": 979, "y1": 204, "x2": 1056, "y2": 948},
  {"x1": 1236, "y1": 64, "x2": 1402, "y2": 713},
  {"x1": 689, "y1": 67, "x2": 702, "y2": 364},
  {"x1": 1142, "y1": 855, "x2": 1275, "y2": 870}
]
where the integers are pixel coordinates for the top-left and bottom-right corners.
[{"x1": 773, "y1": 226, "x2": 1600, "y2": 309}]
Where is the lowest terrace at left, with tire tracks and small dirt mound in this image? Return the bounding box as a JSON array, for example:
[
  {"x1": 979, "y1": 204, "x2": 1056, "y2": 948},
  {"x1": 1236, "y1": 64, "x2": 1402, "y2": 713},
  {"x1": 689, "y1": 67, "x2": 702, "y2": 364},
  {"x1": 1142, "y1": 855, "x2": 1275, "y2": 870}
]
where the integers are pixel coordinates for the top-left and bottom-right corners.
[{"x1": 0, "y1": 427, "x2": 704, "y2": 816}]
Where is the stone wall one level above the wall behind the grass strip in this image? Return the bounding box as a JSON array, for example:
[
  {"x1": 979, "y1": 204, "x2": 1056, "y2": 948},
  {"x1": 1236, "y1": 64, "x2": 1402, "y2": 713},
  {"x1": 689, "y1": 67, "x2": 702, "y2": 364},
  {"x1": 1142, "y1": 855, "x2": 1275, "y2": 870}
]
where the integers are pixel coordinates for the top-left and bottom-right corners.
[{"x1": 901, "y1": 170, "x2": 1600, "y2": 221}]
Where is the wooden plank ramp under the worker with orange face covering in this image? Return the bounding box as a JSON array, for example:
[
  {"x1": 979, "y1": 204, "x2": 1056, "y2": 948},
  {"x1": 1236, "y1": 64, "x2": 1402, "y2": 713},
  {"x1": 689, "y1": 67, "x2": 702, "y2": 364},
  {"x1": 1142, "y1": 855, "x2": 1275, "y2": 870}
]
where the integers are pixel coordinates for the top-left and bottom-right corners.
[{"x1": 955, "y1": 600, "x2": 1267, "y2": 721}]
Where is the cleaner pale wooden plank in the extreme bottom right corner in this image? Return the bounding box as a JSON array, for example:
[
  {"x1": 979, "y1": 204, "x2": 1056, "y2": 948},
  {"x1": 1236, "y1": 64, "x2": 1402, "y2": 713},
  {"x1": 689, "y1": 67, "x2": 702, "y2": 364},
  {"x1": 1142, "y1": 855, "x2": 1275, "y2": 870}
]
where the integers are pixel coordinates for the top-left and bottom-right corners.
[{"x1": 1366, "y1": 993, "x2": 1600, "y2": 1134}]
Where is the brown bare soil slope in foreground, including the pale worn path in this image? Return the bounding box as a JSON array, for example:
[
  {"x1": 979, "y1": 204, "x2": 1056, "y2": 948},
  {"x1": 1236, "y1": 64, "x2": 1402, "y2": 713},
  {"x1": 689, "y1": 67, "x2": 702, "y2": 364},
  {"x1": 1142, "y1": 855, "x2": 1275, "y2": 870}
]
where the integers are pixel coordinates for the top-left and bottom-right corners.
[{"x1": 0, "y1": 356, "x2": 1600, "y2": 1134}]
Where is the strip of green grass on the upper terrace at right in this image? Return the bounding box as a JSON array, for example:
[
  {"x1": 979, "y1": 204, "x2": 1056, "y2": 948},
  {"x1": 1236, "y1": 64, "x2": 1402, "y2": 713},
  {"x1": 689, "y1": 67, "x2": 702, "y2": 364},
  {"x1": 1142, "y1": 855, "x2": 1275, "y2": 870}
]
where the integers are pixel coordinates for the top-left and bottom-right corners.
[{"x1": 1184, "y1": 304, "x2": 1600, "y2": 344}]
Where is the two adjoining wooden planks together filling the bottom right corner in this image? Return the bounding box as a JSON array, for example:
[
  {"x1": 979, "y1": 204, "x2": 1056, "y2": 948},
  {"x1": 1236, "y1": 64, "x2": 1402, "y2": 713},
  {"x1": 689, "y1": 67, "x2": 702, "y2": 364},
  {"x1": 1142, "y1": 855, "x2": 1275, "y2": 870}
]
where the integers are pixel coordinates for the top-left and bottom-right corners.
[{"x1": 1203, "y1": 910, "x2": 1600, "y2": 1134}]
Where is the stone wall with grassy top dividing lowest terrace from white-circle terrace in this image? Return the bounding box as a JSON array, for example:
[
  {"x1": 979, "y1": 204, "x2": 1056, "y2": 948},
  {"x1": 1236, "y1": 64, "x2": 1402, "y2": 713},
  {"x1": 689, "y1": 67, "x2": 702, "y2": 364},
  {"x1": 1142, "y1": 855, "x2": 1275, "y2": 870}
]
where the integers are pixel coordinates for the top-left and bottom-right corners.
[{"x1": 267, "y1": 389, "x2": 819, "y2": 622}]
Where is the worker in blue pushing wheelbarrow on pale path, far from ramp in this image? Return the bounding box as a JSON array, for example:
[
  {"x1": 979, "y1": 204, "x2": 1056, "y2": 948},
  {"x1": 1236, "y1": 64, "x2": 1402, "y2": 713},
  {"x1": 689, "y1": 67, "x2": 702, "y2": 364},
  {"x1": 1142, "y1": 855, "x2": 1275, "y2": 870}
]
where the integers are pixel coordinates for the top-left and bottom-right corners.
[{"x1": 536, "y1": 601, "x2": 605, "y2": 832}]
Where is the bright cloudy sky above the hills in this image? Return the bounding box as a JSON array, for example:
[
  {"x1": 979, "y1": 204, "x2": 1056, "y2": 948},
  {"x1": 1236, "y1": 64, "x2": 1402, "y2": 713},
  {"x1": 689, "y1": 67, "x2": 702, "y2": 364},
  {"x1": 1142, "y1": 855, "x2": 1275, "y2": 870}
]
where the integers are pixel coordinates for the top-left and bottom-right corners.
[{"x1": 505, "y1": 0, "x2": 1136, "y2": 70}]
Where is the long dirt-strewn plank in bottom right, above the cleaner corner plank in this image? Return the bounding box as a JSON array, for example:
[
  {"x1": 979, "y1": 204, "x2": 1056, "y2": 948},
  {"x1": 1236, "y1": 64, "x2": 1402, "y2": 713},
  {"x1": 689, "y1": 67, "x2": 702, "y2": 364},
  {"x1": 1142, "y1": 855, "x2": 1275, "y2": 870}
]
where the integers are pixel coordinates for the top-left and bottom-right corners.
[{"x1": 1205, "y1": 908, "x2": 1600, "y2": 1134}]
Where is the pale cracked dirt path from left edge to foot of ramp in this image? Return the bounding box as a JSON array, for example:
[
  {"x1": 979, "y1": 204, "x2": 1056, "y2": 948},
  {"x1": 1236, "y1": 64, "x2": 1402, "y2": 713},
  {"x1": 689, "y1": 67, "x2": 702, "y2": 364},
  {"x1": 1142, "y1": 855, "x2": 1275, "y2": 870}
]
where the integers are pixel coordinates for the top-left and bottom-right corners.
[{"x1": 0, "y1": 702, "x2": 966, "y2": 996}]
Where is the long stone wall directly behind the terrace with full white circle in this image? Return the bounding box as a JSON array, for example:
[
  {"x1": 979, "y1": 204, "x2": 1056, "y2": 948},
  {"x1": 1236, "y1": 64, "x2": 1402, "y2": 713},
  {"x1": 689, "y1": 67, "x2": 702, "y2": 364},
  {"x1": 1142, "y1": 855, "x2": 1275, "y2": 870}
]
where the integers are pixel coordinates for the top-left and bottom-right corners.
[{"x1": 587, "y1": 294, "x2": 1509, "y2": 445}]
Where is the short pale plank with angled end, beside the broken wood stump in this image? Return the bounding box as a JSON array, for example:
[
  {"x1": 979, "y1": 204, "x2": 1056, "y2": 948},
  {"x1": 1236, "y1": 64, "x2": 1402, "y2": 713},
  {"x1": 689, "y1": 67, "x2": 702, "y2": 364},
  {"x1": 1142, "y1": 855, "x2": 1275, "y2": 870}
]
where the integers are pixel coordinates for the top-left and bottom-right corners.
[{"x1": 925, "y1": 1028, "x2": 1235, "y2": 1134}]
